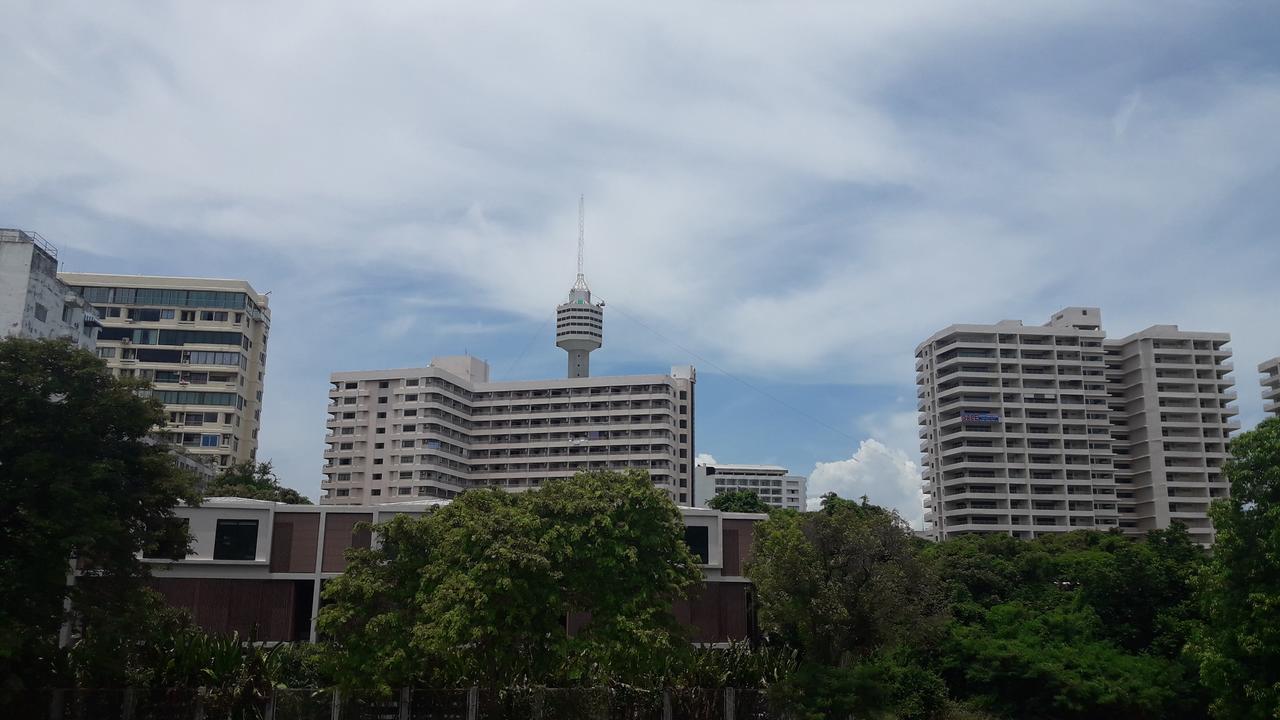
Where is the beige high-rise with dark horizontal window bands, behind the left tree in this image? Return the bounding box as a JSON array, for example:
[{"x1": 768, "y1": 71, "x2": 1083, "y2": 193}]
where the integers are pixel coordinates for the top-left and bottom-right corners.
[{"x1": 60, "y1": 273, "x2": 271, "y2": 466}]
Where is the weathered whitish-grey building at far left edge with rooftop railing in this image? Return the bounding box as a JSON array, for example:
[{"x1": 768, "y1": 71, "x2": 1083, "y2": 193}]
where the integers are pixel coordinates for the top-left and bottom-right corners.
[{"x1": 0, "y1": 228, "x2": 101, "y2": 350}]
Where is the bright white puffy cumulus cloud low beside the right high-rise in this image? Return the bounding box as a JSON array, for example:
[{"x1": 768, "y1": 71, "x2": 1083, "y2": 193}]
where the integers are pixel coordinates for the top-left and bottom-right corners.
[{"x1": 808, "y1": 439, "x2": 924, "y2": 528}]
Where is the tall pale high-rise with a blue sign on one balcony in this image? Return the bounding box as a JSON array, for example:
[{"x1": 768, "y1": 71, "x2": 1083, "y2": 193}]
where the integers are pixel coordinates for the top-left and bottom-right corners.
[{"x1": 915, "y1": 307, "x2": 1239, "y2": 544}]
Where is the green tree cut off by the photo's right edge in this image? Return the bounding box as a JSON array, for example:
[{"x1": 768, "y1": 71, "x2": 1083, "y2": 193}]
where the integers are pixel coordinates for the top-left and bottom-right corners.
[{"x1": 1198, "y1": 418, "x2": 1280, "y2": 720}]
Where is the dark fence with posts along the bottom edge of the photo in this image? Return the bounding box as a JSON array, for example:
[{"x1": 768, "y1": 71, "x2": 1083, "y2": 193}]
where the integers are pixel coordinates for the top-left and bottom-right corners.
[{"x1": 24, "y1": 688, "x2": 788, "y2": 720}]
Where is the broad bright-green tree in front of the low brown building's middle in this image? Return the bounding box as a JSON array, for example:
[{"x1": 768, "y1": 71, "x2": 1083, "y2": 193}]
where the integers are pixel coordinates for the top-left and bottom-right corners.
[{"x1": 319, "y1": 471, "x2": 701, "y2": 688}]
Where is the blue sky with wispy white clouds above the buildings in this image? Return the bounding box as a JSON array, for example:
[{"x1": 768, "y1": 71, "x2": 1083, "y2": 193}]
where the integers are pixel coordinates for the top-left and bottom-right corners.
[{"x1": 0, "y1": 0, "x2": 1280, "y2": 525}]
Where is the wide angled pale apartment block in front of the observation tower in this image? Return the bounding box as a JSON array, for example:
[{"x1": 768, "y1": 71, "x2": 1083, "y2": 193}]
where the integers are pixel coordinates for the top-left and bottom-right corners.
[{"x1": 320, "y1": 356, "x2": 696, "y2": 505}]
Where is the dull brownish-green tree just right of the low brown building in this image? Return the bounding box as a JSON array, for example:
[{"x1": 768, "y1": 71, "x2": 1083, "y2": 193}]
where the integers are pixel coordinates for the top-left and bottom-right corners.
[{"x1": 746, "y1": 495, "x2": 947, "y2": 719}]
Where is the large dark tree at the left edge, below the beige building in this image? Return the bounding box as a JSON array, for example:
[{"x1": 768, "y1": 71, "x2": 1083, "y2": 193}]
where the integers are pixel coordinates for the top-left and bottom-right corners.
[{"x1": 0, "y1": 338, "x2": 198, "y2": 694}]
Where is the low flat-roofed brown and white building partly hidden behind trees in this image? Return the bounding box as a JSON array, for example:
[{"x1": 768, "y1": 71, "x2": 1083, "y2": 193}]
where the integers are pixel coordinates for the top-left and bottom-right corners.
[{"x1": 143, "y1": 497, "x2": 765, "y2": 643}]
